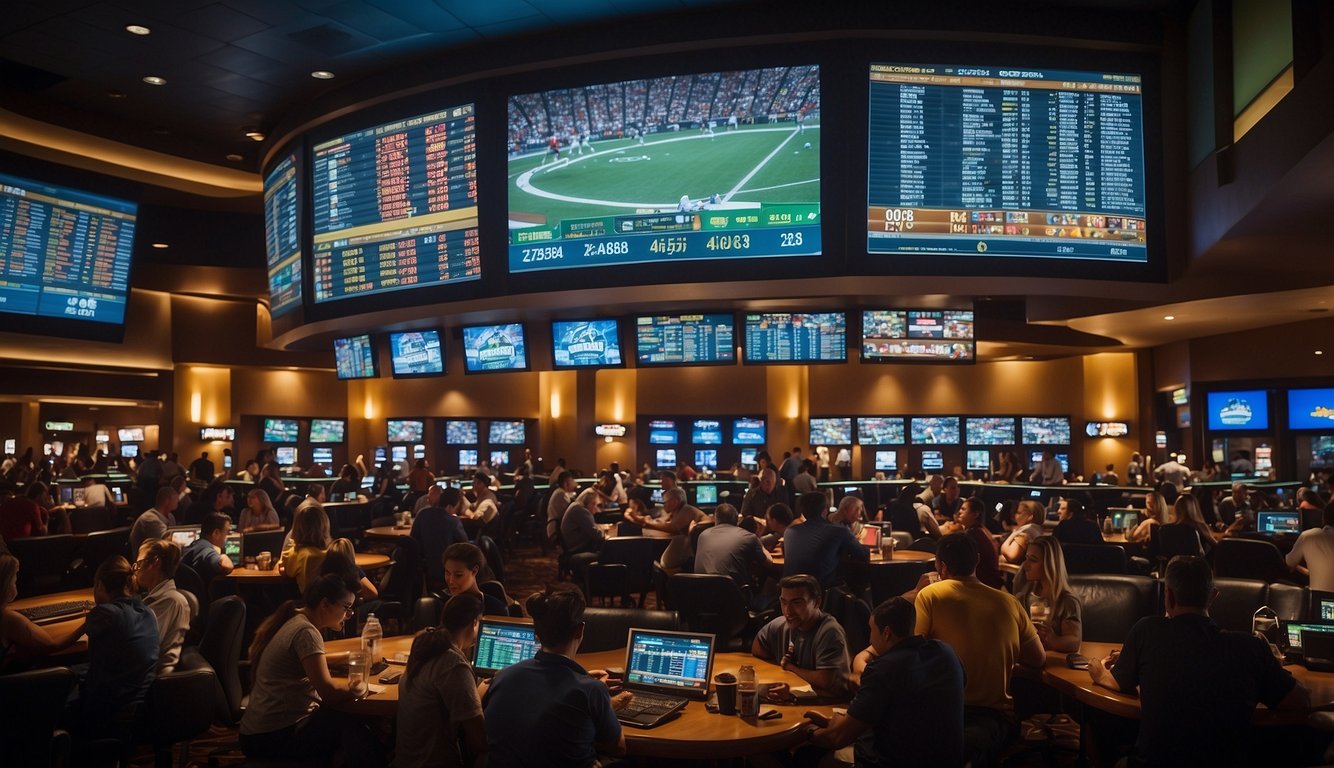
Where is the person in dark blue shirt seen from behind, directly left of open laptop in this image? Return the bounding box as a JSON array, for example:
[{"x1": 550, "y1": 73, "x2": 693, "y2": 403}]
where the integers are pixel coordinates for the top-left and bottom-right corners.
[{"x1": 482, "y1": 588, "x2": 631, "y2": 768}]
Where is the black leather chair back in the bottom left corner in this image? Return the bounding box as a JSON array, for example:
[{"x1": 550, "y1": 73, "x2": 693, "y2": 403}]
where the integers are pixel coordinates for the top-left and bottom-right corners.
[{"x1": 0, "y1": 667, "x2": 76, "y2": 768}]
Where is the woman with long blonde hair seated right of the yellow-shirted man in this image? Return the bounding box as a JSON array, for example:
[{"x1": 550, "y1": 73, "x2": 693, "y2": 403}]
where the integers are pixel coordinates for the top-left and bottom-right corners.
[{"x1": 1014, "y1": 536, "x2": 1083, "y2": 653}]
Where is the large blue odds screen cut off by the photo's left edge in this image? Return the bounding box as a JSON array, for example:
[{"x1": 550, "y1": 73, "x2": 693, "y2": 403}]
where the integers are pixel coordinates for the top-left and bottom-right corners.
[{"x1": 0, "y1": 173, "x2": 139, "y2": 325}]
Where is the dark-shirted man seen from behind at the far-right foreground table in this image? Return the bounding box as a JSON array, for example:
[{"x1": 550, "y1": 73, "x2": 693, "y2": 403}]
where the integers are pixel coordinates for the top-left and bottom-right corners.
[{"x1": 1089, "y1": 557, "x2": 1310, "y2": 765}]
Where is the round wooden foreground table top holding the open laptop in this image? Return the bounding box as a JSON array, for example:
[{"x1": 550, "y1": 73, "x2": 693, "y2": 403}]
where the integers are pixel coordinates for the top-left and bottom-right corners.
[{"x1": 324, "y1": 635, "x2": 846, "y2": 760}]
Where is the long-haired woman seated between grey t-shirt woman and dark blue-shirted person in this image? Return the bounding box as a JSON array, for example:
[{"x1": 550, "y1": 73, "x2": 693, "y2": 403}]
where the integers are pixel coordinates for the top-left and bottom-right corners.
[{"x1": 394, "y1": 593, "x2": 487, "y2": 768}]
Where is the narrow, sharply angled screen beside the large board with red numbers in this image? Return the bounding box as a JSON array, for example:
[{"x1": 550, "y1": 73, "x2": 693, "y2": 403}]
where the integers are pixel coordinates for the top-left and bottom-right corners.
[{"x1": 264, "y1": 155, "x2": 301, "y2": 317}]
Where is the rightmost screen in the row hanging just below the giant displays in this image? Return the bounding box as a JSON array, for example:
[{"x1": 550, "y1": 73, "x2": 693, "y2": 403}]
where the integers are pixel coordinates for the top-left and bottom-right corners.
[{"x1": 862, "y1": 309, "x2": 976, "y2": 363}]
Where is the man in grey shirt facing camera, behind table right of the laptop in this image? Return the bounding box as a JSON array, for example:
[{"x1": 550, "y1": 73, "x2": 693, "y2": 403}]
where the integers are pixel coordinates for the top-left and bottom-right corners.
[{"x1": 751, "y1": 576, "x2": 851, "y2": 699}]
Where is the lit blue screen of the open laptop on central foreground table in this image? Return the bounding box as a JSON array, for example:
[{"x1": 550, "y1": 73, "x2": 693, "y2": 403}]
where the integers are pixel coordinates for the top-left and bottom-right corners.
[{"x1": 626, "y1": 629, "x2": 714, "y2": 699}]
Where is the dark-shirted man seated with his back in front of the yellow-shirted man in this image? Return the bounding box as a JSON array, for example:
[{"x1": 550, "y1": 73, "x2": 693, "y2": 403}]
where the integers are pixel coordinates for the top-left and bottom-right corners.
[{"x1": 811, "y1": 597, "x2": 963, "y2": 767}]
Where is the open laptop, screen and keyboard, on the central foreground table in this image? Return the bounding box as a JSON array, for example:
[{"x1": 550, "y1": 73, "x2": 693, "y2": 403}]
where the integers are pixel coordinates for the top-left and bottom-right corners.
[{"x1": 616, "y1": 629, "x2": 714, "y2": 728}]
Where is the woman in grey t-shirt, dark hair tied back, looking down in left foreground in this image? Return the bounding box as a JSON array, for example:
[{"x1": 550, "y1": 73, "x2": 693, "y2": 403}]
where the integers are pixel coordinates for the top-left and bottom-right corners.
[{"x1": 240, "y1": 575, "x2": 383, "y2": 765}]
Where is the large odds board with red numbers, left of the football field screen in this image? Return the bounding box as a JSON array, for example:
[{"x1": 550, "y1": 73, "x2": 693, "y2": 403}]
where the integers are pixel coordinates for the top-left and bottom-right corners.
[{"x1": 311, "y1": 104, "x2": 482, "y2": 303}]
